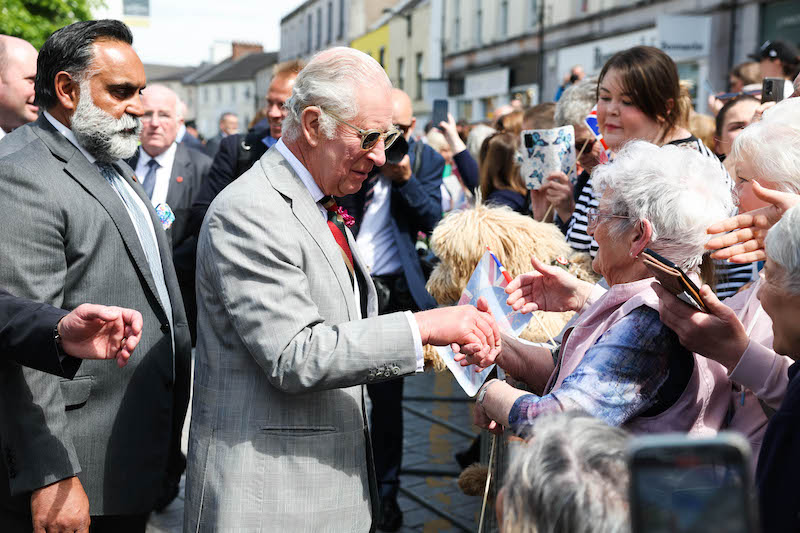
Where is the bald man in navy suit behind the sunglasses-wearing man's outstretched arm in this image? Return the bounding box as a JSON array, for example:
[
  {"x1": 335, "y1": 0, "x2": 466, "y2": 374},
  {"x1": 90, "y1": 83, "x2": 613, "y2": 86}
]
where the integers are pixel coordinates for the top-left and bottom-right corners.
[{"x1": 339, "y1": 89, "x2": 444, "y2": 531}]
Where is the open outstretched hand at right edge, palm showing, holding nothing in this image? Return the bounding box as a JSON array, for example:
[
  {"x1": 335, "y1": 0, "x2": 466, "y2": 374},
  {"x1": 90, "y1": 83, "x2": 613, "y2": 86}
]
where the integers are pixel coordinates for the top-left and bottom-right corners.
[{"x1": 706, "y1": 180, "x2": 800, "y2": 263}]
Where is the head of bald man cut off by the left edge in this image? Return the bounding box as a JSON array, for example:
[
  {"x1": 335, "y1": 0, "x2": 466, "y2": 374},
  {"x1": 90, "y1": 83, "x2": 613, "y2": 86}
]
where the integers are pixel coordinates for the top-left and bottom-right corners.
[{"x1": 0, "y1": 35, "x2": 39, "y2": 139}]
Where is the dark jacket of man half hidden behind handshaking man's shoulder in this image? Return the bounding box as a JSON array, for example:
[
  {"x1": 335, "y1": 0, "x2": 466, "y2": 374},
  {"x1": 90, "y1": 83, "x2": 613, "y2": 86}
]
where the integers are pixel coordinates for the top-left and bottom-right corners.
[{"x1": 189, "y1": 128, "x2": 269, "y2": 235}]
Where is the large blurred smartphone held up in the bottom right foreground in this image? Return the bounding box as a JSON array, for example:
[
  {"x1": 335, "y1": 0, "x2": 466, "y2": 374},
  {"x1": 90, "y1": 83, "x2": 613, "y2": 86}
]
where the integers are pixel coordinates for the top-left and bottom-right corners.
[{"x1": 628, "y1": 432, "x2": 759, "y2": 533}]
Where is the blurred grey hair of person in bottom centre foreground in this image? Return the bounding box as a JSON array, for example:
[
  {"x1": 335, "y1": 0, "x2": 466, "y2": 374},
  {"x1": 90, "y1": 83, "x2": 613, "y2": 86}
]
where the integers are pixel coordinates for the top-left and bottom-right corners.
[{"x1": 501, "y1": 411, "x2": 630, "y2": 533}]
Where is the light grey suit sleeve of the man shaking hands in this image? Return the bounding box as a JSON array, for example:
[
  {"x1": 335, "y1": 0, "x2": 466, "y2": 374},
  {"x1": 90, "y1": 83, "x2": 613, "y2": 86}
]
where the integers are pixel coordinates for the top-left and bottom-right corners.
[{"x1": 198, "y1": 187, "x2": 416, "y2": 393}]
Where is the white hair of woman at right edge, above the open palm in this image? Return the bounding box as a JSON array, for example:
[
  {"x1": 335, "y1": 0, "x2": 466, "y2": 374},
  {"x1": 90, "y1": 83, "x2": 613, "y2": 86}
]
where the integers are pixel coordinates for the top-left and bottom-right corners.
[{"x1": 726, "y1": 98, "x2": 800, "y2": 193}]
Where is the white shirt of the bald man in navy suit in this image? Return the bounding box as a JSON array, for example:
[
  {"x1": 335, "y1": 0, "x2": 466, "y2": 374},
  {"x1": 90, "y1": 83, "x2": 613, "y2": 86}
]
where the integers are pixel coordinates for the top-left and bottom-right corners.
[{"x1": 356, "y1": 175, "x2": 403, "y2": 276}]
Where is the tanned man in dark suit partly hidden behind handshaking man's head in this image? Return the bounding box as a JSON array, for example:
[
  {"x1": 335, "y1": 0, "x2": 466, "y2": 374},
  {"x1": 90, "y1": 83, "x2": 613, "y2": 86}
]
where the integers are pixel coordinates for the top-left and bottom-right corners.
[{"x1": 191, "y1": 60, "x2": 304, "y2": 234}]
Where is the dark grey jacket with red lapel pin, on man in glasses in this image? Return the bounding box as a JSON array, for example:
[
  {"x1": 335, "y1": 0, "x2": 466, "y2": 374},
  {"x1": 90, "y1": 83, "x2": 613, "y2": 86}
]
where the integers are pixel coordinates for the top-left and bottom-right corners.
[{"x1": 127, "y1": 142, "x2": 211, "y2": 345}]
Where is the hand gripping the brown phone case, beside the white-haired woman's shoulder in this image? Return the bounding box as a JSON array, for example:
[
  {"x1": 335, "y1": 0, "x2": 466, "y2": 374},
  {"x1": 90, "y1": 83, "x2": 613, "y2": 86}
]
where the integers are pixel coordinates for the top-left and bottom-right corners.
[{"x1": 652, "y1": 282, "x2": 750, "y2": 371}]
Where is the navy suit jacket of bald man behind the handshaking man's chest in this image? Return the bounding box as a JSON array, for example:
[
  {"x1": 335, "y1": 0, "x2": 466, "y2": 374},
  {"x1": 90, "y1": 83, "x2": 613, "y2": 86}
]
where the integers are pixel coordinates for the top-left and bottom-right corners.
[{"x1": 338, "y1": 140, "x2": 444, "y2": 309}]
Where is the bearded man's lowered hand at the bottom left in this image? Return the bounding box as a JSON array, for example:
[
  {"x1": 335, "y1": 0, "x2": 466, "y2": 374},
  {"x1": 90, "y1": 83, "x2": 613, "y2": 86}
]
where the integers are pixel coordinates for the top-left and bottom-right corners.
[{"x1": 31, "y1": 477, "x2": 91, "y2": 533}]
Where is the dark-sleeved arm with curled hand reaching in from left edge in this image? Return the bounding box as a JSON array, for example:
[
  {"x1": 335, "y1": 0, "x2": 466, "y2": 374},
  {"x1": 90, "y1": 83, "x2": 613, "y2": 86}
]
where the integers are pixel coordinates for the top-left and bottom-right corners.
[{"x1": 0, "y1": 289, "x2": 142, "y2": 378}]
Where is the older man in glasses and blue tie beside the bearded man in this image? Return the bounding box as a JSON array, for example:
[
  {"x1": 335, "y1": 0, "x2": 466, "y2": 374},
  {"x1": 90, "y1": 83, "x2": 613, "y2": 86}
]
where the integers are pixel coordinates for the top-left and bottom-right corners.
[{"x1": 127, "y1": 81, "x2": 211, "y2": 344}]
